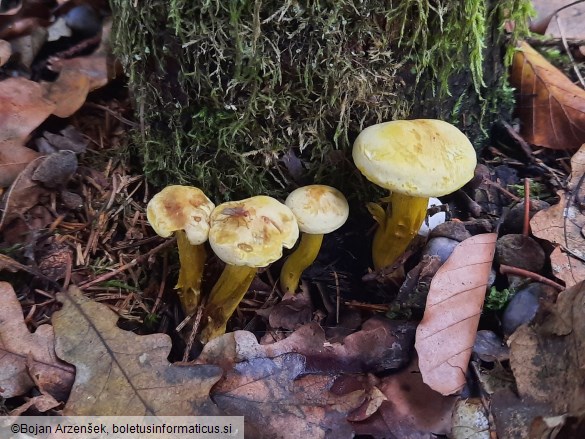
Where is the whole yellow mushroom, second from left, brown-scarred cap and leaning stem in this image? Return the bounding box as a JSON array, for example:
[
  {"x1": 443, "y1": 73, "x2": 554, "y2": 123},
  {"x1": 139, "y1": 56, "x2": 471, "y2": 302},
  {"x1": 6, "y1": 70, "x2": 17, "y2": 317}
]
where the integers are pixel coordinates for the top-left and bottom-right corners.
[{"x1": 201, "y1": 195, "x2": 299, "y2": 341}]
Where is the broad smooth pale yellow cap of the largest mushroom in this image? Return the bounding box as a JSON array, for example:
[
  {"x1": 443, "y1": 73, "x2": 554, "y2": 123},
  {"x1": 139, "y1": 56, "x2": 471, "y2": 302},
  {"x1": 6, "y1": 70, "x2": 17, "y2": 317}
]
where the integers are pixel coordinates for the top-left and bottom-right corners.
[{"x1": 353, "y1": 119, "x2": 477, "y2": 197}]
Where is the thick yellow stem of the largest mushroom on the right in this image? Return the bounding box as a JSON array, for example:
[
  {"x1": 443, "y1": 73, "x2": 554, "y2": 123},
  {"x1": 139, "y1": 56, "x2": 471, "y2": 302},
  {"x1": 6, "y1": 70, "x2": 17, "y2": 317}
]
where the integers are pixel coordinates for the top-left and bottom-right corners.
[{"x1": 372, "y1": 192, "x2": 429, "y2": 270}]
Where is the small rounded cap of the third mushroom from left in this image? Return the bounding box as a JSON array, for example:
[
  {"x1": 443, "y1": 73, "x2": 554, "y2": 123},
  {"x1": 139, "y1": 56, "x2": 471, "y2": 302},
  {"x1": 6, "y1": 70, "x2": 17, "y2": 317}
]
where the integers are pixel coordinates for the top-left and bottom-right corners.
[{"x1": 284, "y1": 184, "x2": 349, "y2": 234}]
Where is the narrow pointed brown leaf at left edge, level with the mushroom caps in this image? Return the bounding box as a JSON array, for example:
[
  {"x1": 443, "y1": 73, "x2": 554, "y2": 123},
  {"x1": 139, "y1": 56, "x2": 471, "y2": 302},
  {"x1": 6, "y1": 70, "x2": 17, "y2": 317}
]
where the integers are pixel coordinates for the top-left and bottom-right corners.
[{"x1": 0, "y1": 156, "x2": 47, "y2": 230}]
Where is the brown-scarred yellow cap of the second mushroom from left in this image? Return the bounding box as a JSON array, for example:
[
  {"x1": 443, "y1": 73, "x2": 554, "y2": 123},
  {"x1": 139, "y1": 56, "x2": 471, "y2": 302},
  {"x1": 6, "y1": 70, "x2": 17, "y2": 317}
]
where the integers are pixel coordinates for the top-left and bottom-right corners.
[{"x1": 209, "y1": 195, "x2": 299, "y2": 267}]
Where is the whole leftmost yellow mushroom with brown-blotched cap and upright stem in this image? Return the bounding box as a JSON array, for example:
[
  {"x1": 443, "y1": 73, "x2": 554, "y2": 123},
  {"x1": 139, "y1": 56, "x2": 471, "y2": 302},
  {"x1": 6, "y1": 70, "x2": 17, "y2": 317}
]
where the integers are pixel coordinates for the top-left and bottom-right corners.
[{"x1": 146, "y1": 185, "x2": 215, "y2": 315}]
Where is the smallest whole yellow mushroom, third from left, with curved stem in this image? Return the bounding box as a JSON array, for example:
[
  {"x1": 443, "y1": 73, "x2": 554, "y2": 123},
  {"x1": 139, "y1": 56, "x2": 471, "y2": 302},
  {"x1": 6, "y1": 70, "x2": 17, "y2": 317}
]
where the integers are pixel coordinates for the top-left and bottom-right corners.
[{"x1": 280, "y1": 184, "x2": 349, "y2": 293}]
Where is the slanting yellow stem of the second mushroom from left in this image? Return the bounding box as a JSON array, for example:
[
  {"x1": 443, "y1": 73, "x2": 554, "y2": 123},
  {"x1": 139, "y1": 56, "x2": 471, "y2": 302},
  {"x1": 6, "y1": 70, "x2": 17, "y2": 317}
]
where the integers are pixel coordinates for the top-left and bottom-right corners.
[{"x1": 201, "y1": 264, "x2": 258, "y2": 343}]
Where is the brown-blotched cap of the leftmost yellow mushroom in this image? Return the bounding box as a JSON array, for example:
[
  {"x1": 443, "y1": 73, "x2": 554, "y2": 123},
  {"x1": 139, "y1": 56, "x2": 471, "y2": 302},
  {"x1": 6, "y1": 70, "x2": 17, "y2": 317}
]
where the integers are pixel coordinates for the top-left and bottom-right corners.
[{"x1": 146, "y1": 185, "x2": 215, "y2": 245}]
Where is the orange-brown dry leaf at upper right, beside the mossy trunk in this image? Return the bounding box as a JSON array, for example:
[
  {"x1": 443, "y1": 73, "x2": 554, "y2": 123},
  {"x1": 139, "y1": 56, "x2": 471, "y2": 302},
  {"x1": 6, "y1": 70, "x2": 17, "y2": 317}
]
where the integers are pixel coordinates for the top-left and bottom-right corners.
[{"x1": 510, "y1": 42, "x2": 585, "y2": 150}]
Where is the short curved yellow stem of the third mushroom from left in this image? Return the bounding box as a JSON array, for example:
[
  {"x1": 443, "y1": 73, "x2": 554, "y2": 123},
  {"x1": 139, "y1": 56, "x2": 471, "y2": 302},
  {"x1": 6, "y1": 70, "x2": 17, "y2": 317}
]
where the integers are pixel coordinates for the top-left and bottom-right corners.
[{"x1": 280, "y1": 233, "x2": 323, "y2": 294}]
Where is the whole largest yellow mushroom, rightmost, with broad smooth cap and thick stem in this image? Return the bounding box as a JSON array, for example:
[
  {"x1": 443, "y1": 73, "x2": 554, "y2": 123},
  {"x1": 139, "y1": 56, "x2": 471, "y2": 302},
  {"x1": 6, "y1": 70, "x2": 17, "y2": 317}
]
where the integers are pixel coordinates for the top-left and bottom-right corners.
[{"x1": 353, "y1": 119, "x2": 477, "y2": 269}]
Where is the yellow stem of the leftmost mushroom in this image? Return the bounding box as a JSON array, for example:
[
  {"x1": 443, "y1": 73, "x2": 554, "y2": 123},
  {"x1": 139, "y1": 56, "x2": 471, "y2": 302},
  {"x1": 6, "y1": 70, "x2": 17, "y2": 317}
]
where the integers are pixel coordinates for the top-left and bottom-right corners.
[{"x1": 175, "y1": 230, "x2": 207, "y2": 315}]
